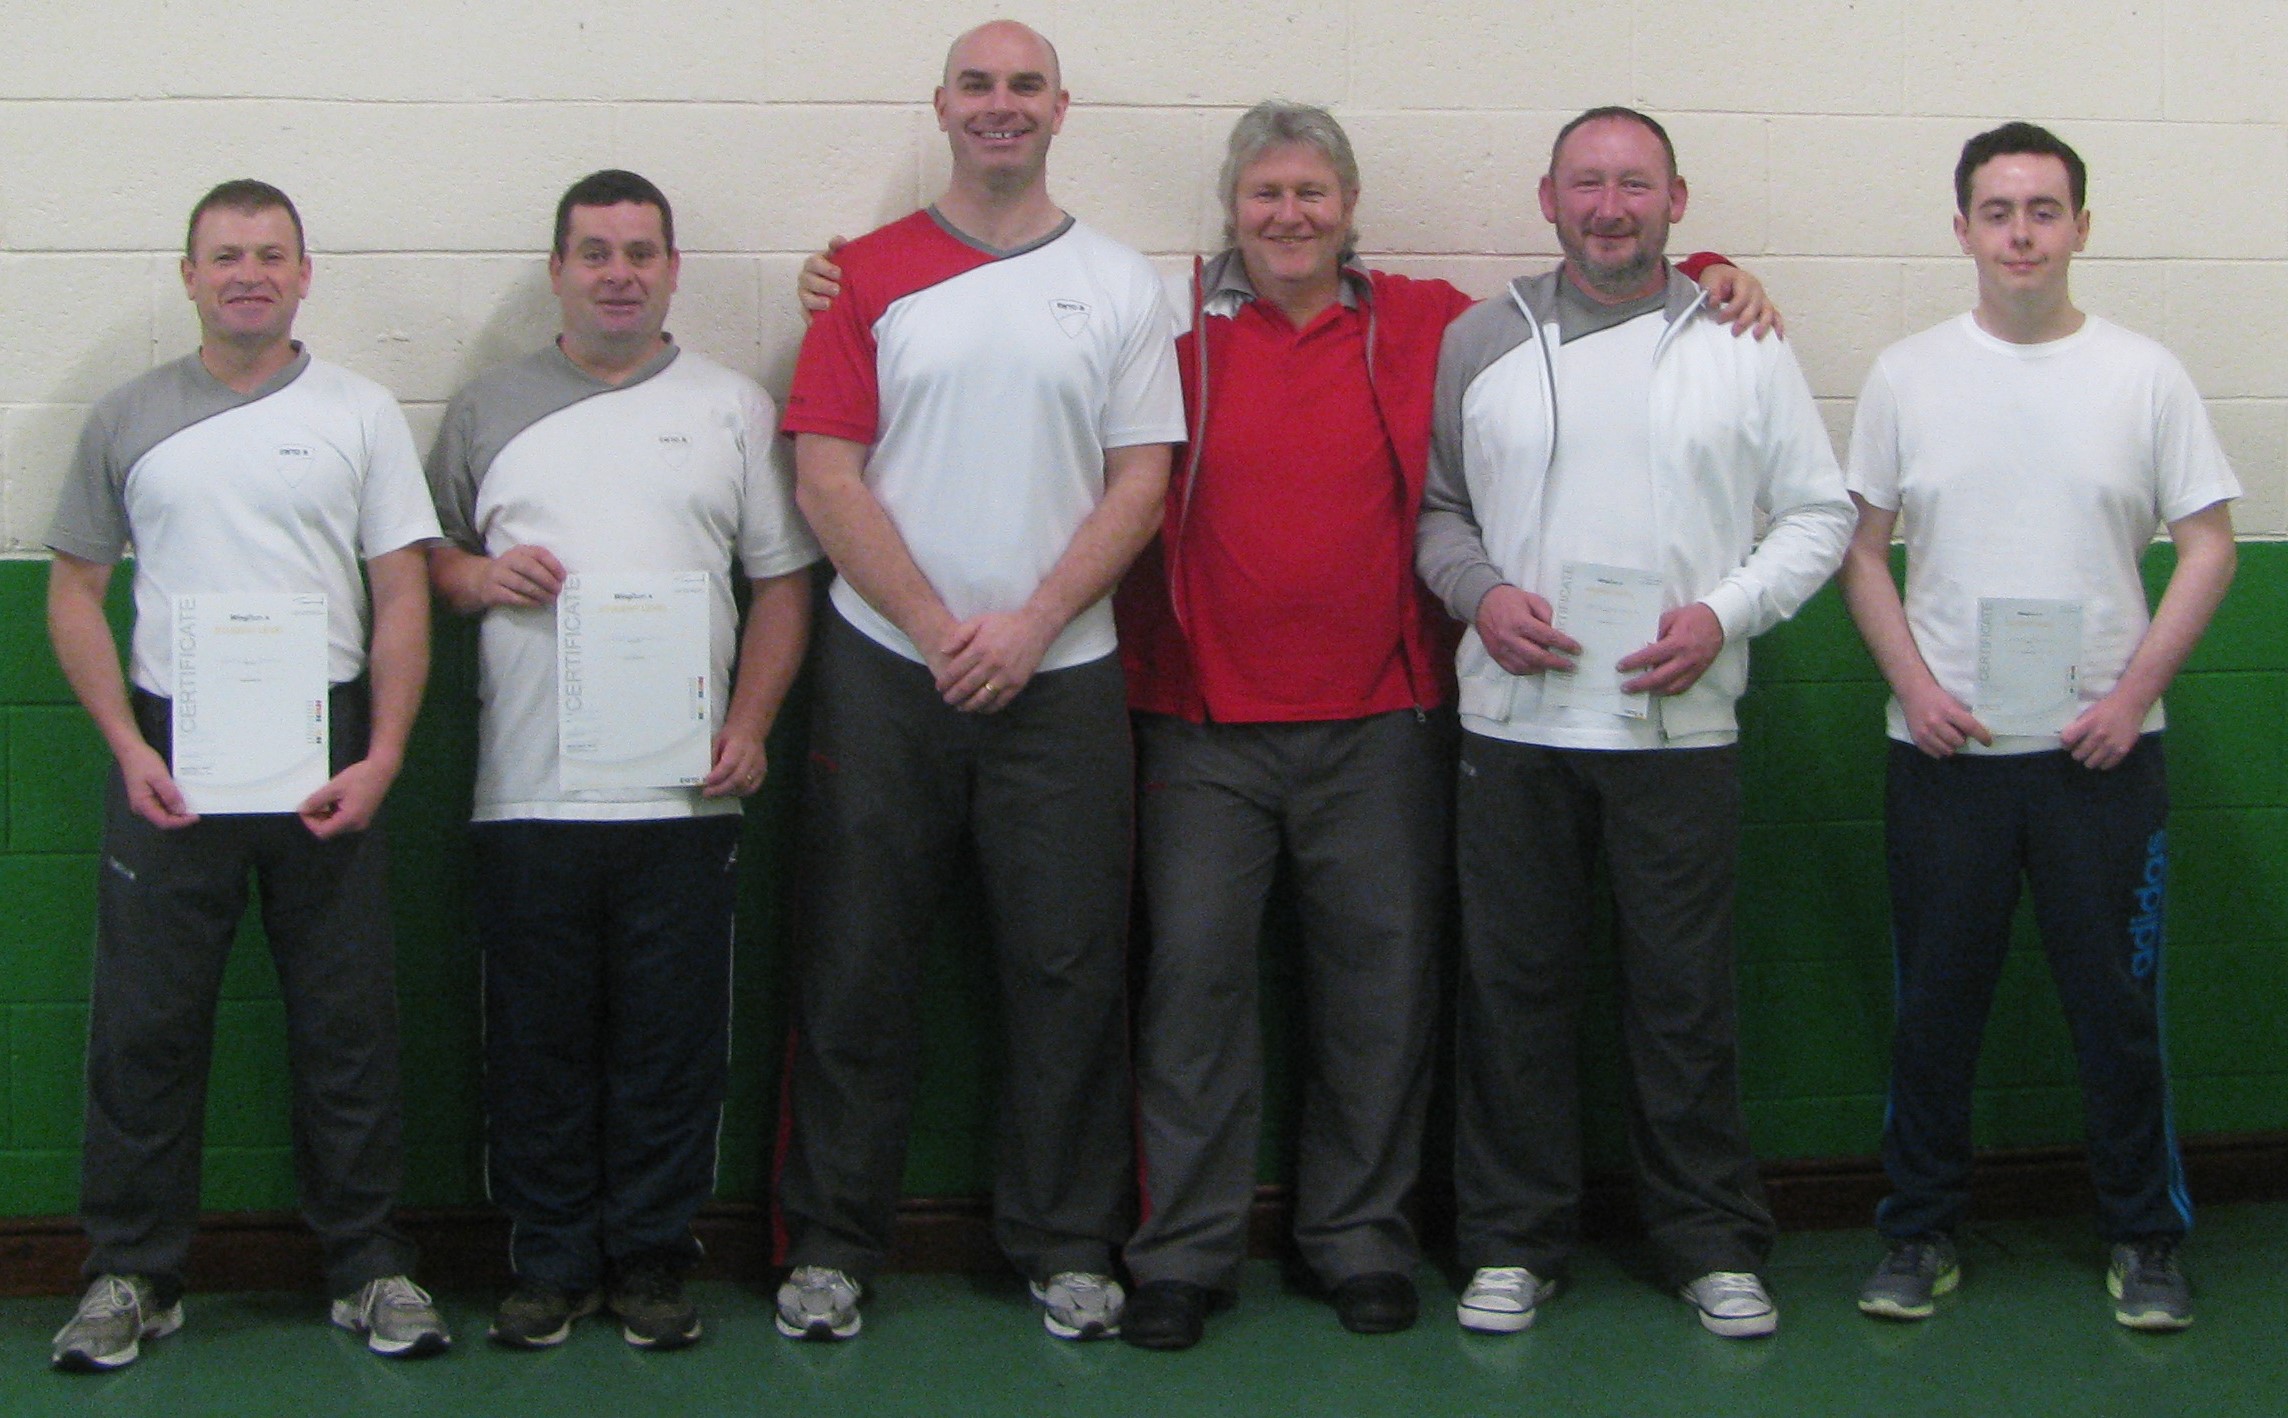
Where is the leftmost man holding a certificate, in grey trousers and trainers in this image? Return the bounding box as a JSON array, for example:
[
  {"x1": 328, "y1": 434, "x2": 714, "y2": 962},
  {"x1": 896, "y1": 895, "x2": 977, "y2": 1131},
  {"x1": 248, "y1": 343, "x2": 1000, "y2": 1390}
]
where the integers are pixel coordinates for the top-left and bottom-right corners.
[{"x1": 48, "y1": 181, "x2": 451, "y2": 1372}]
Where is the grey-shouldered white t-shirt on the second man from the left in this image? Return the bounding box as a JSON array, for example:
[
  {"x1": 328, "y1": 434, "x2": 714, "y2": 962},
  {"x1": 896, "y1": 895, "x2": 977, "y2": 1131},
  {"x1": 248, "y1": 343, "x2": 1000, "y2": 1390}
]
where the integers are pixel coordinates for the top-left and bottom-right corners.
[{"x1": 430, "y1": 345, "x2": 819, "y2": 821}]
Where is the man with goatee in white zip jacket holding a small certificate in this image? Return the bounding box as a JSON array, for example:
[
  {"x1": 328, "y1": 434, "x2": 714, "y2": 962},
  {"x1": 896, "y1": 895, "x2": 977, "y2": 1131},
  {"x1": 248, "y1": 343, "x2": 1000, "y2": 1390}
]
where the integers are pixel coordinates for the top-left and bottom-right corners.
[{"x1": 1416, "y1": 107, "x2": 1851, "y2": 1338}]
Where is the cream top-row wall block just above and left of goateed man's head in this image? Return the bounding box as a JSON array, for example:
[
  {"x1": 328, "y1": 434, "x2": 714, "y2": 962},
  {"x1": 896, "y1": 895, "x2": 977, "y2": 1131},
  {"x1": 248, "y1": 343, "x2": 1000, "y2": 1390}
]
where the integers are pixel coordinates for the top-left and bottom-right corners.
[{"x1": 1350, "y1": 0, "x2": 1643, "y2": 111}]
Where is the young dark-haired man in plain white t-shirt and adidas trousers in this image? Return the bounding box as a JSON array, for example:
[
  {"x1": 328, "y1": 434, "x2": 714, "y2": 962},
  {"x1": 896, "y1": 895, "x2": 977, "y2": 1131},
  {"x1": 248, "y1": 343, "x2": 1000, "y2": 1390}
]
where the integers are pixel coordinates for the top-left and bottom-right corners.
[{"x1": 1842, "y1": 124, "x2": 2240, "y2": 1331}]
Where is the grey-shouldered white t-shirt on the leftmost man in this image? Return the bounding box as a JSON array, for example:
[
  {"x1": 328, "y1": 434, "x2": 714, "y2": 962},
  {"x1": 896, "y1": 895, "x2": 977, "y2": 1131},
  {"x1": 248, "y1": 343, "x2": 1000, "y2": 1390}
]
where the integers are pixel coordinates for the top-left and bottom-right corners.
[{"x1": 48, "y1": 350, "x2": 437, "y2": 695}]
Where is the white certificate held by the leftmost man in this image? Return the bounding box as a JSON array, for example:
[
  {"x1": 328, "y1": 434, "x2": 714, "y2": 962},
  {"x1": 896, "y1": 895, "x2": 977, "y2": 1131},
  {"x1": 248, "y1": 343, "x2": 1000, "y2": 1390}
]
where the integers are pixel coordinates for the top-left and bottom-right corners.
[{"x1": 174, "y1": 595, "x2": 327, "y2": 814}]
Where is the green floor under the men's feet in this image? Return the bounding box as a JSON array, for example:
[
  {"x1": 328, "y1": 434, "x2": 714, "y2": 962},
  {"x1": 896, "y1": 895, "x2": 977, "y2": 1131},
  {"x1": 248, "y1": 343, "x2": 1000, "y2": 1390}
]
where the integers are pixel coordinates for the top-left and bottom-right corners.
[{"x1": 0, "y1": 1205, "x2": 2288, "y2": 1418}]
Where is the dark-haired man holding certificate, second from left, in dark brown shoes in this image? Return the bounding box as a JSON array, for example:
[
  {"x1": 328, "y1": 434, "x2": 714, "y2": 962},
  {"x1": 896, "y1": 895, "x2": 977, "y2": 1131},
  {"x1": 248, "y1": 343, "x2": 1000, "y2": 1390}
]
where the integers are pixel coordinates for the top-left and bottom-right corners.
[{"x1": 428, "y1": 169, "x2": 819, "y2": 1349}]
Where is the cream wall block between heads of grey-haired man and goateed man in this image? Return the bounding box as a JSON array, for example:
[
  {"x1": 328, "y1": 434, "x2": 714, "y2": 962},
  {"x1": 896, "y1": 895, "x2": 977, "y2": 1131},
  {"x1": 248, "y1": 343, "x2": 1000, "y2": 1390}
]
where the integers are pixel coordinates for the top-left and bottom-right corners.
[{"x1": 1343, "y1": 110, "x2": 1567, "y2": 254}]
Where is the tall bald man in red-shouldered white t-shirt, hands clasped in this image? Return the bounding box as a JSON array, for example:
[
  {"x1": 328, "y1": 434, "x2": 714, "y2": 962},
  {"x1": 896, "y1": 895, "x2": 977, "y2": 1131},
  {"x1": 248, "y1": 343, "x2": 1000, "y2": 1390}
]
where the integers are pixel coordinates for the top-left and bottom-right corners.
[{"x1": 778, "y1": 21, "x2": 1183, "y2": 1340}]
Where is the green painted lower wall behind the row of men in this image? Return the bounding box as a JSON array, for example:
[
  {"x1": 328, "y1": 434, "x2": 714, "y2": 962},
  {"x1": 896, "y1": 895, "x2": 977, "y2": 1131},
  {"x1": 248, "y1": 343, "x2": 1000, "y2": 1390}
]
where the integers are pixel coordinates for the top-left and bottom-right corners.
[{"x1": 0, "y1": 542, "x2": 2288, "y2": 1217}]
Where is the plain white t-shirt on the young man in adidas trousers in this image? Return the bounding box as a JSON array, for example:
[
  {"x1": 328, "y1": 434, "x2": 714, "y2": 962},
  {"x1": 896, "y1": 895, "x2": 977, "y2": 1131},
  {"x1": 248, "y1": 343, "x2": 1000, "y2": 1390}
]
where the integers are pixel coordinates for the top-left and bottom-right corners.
[{"x1": 1849, "y1": 316, "x2": 2240, "y2": 752}]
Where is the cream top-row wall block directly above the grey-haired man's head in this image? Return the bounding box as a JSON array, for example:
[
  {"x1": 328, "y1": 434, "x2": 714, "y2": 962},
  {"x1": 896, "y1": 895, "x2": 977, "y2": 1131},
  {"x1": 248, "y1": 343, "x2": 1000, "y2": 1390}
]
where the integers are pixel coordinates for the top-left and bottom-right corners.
[{"x1": 1050, "y1": 0, "x2": 1354, "y2": 107}]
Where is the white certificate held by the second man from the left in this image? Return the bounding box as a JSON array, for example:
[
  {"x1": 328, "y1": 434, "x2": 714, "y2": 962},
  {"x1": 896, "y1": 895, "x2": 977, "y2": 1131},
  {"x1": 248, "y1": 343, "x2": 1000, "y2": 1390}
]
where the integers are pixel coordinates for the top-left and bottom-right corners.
[{"x1": 556, "y1": 572, "x2": 712, "y2": 789}]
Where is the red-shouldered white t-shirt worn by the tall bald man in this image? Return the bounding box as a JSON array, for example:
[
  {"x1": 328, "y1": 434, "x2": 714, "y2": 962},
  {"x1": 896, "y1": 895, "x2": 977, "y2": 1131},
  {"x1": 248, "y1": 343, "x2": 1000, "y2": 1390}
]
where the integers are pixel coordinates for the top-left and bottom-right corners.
[{"x1": 780, "y1": 208, "x2": 1185, "y2": 670}]
